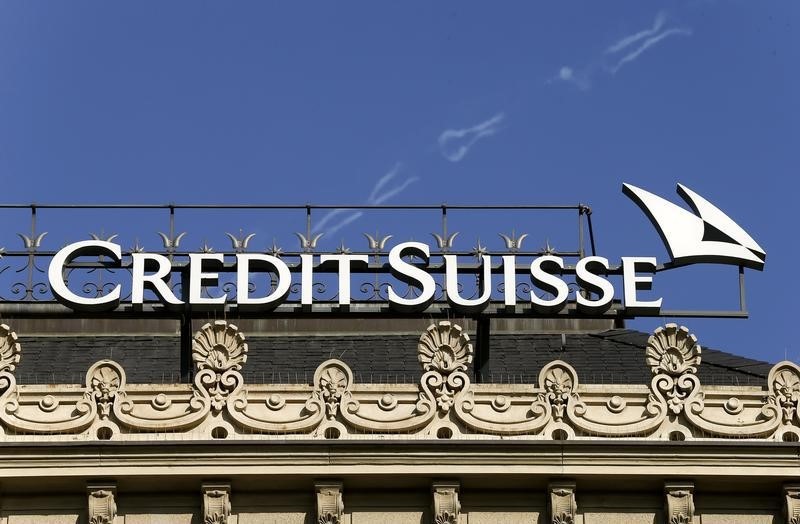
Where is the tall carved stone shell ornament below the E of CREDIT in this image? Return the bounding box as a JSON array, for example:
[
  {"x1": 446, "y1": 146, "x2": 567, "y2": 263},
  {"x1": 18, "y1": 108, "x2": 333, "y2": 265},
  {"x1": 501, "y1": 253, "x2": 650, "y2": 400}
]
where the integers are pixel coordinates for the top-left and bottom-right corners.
[{"x1": 192, "y1": 320, "x2": 247, "y2": 413}]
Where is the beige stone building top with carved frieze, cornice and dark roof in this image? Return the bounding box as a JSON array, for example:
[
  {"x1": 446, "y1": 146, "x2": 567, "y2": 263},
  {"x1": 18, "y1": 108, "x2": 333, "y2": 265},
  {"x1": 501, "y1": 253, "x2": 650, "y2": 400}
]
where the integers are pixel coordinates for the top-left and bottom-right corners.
[{"x1": 0, "y1": 315, "x2": 800, "y2": 524}]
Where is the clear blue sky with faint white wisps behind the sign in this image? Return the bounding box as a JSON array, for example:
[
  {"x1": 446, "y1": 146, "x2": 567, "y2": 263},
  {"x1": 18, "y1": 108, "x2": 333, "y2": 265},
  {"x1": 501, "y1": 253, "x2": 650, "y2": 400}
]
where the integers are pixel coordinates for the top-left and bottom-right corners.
[{"x1": 0, "y1": 0, "x2": 800, "y2": 361}]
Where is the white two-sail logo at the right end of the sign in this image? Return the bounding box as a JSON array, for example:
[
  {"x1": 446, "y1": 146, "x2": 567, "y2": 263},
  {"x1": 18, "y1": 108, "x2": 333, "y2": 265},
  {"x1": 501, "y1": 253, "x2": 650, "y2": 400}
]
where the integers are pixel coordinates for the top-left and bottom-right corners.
[{"x1": 622, "y1": 184, "x2": 767, "y2": 270}]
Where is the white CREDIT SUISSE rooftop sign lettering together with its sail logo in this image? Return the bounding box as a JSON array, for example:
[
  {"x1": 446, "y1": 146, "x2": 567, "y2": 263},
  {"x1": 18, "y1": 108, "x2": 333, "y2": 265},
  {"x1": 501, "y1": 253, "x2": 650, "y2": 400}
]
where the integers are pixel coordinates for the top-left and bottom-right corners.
[{"x1": 0, "y1": 184, "x2": 766, "y2": 316}]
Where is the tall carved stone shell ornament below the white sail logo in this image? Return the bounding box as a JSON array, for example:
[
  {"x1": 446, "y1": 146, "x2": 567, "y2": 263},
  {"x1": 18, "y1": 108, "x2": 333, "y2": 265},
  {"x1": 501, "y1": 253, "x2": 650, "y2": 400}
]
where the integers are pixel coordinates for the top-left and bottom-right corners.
[{"x1": 645, "y1": 324, "x2": 701, "y2": 415}]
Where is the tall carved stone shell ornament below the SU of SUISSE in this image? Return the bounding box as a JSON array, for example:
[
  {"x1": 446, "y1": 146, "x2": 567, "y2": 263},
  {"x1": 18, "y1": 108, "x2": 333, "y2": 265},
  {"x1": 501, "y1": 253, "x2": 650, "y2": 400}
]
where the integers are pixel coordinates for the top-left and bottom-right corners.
[{"x1": 417, "y1": 320, "x2": 473, "y2": 413}]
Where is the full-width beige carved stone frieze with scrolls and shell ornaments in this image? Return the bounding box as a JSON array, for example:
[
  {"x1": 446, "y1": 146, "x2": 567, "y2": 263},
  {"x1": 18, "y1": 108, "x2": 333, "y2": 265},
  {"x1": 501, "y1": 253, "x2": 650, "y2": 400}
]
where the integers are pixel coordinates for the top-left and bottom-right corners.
[{"x1": 0, "y1": 321, "x2": 800, "y2": 441}]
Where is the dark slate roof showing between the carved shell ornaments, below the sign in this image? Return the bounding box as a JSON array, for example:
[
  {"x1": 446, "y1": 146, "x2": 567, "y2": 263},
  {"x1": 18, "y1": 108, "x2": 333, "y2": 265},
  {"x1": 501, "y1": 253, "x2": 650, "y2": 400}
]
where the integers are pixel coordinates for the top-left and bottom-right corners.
[{"x1": 16, "y1": 329, "x2": 771, "y2": 385}]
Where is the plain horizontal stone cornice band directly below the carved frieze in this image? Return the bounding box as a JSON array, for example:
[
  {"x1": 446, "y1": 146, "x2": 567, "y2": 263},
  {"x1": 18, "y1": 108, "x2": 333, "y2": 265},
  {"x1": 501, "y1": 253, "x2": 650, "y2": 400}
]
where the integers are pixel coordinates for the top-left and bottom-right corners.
[{"x1": 0, "y1": 440, "x2": 800, "y2": 479}]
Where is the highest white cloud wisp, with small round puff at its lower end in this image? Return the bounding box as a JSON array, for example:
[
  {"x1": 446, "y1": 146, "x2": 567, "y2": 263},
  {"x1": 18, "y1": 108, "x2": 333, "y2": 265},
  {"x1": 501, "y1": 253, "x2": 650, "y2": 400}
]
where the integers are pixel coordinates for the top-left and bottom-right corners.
[{"x1": 546, "y1": 11, "x2": 692, "y2": 91}]
